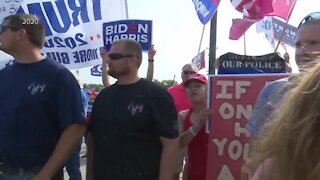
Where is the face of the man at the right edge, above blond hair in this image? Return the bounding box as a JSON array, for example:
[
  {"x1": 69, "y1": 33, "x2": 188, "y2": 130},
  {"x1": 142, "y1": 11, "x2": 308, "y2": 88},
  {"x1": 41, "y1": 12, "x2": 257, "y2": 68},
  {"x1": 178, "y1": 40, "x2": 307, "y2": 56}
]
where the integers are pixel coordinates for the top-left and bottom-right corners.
[{"x1": 295, "y1": 22, "x2": 320, "y2": 69}]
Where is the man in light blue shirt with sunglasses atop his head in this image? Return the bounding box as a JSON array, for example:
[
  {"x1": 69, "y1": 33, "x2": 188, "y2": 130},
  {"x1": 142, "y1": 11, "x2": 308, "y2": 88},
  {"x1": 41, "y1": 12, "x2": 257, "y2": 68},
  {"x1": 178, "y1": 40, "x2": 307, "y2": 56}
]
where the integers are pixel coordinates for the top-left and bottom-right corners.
[{"x1": 248, "y1": 12, "x2": 320, "y2": 136}]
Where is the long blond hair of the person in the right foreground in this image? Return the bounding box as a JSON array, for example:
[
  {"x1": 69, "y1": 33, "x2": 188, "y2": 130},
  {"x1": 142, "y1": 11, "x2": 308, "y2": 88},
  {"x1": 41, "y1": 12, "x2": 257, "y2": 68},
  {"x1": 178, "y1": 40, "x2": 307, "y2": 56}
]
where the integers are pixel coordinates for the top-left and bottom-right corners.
[{"x1": 246, "y1": 58, "x2": 320, "y2": 180}]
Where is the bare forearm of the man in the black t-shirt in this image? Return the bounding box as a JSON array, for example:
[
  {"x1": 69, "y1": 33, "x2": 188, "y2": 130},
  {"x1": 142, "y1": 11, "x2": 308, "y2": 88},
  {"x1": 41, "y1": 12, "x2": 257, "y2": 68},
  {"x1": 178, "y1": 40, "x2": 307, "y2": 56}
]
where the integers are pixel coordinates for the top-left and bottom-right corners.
[{"x1": 159, "y1": 137, "x2": 179, "y2": 180}]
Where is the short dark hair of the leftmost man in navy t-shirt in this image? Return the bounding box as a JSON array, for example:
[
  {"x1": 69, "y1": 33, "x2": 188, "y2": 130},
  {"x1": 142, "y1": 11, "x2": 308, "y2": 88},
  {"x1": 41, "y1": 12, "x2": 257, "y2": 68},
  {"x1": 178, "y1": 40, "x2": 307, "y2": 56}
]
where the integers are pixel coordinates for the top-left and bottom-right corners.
[{"x1": 2, "y1": 14, "x2": 46, "y2": 48}]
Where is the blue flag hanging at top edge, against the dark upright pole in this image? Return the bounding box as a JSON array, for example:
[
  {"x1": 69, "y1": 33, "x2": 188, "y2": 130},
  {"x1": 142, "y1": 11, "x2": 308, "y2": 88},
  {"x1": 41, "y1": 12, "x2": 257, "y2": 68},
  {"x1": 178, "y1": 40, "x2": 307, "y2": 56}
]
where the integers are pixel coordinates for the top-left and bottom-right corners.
[{"x1": 192, "y1": 0, "x2": 221, "y2": 25}]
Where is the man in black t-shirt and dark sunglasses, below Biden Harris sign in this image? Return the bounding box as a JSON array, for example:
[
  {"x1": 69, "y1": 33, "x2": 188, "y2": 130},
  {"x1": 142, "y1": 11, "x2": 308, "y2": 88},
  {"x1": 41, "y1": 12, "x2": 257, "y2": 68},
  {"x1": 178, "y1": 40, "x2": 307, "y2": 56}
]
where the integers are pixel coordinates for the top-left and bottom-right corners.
[{"x1": 87, "y1": 40, "x2": 179, "y2": 180}]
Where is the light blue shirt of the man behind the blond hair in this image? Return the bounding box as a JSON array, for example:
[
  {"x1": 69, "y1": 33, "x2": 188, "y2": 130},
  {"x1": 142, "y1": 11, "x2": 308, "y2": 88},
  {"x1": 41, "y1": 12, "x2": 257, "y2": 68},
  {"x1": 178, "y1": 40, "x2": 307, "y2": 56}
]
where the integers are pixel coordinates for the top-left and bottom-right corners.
[{"x1": 247, "y1": 78, "x2": 289, "y2": 136}]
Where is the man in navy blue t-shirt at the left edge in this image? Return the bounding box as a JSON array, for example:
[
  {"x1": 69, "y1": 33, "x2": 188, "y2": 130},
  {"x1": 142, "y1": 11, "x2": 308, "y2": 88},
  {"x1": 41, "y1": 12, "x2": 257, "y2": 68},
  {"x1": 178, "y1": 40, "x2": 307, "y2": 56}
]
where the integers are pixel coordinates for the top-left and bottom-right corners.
[{"x1": 0, "y1": 14, "x2": 86, "y2": 180}]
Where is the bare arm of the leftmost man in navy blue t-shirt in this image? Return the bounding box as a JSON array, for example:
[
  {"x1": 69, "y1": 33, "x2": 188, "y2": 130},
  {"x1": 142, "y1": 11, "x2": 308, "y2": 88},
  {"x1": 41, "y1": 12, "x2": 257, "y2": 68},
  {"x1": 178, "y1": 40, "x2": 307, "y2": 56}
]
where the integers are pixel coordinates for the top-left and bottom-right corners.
[{"x1": 34, "y1": 124, "x2": 86, "y2": 180}]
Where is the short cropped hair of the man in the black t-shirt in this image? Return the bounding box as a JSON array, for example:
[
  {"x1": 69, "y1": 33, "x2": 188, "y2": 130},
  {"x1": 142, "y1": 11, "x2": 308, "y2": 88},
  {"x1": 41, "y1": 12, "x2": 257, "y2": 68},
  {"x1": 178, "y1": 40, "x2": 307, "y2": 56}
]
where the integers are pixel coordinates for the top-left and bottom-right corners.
[{"x1": 112, "y1": 39, "x2": 142, "y2": 67}]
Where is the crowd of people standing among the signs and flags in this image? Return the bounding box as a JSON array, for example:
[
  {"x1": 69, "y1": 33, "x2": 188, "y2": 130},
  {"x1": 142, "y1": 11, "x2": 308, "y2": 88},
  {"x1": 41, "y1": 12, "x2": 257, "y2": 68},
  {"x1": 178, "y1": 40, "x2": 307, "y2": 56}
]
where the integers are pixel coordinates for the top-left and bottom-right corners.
[{"x1": 0, "y1": 12, "x2": 320, "y2": 180}]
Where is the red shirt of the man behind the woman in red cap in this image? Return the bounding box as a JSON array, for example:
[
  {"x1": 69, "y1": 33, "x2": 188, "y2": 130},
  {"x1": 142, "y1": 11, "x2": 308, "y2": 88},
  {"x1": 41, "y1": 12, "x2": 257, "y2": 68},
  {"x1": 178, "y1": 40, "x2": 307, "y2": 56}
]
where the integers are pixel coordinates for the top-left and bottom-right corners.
[{"x1": 168, "y1": 83, "x2": 192, "y2": 112}]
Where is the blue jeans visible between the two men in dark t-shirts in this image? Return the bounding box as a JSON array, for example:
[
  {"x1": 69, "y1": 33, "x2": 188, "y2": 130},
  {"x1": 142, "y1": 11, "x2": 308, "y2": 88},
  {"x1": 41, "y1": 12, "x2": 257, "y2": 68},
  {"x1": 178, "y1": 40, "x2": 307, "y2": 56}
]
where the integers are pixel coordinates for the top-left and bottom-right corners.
[{"x1": 66, "y1": 140, "x2": 82, "y2": 180}]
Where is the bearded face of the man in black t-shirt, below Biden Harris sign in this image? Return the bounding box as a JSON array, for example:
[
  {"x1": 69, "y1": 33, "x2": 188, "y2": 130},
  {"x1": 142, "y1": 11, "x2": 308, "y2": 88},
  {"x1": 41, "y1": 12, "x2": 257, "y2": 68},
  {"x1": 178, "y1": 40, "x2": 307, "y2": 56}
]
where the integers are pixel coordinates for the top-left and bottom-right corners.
[{"x1": 107, "y1": 44, "x2": 135, "y2": 78}]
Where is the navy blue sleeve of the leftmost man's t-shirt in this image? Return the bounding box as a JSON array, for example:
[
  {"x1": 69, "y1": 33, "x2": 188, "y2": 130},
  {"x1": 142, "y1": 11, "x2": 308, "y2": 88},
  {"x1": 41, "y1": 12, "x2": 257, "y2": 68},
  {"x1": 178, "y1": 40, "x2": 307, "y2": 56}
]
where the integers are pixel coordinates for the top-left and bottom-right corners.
[{"x1": 56, "y1": 69, "x2": 85, "y2": 129}]
